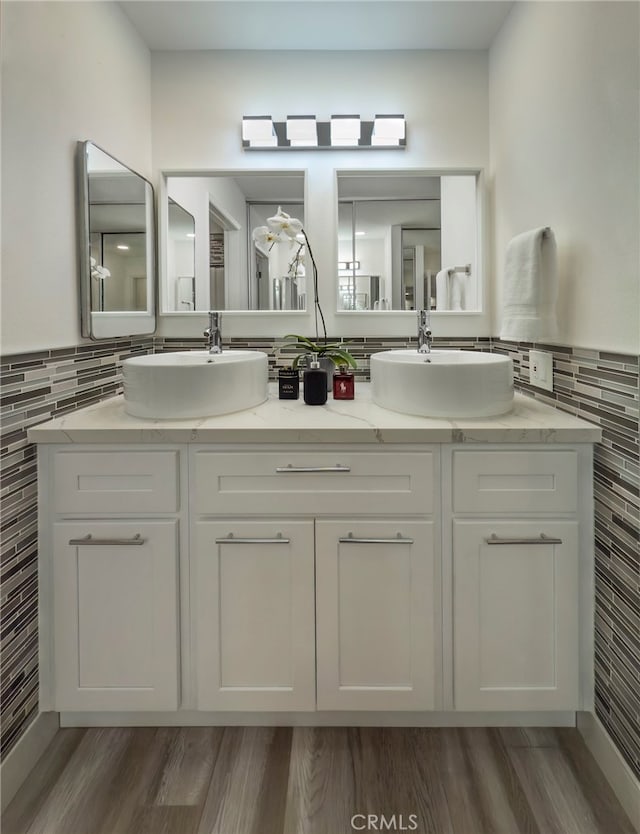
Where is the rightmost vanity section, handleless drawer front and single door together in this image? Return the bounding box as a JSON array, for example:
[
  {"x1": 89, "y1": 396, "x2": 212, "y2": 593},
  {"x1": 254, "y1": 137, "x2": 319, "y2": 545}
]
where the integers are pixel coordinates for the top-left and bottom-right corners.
[{"x1": 452, "y1": 448, "x2": 580, "y2": 710}]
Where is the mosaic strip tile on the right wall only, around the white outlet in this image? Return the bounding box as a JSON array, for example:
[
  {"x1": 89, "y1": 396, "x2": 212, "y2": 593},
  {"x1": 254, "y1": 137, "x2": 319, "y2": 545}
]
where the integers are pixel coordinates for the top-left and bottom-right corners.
[{"x1": 493, "y1": 339, "x2": 640, "y2": 778}]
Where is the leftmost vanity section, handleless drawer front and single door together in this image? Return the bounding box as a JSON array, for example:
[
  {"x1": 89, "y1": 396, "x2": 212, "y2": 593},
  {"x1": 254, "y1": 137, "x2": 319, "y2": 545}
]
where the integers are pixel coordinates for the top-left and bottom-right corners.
[{"x1": 39, "y1": 447, "x2": 180, "y2": 711}]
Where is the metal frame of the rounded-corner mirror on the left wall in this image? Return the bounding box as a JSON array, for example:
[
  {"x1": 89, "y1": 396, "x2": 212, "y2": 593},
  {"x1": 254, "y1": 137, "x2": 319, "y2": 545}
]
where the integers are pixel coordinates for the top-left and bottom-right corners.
[{"x1": 76, "y1": 140, "x2": 158, "y2": 341}]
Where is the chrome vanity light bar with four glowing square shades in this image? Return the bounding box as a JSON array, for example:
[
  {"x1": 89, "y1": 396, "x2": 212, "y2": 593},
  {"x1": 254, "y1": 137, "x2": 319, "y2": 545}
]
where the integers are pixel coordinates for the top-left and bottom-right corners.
[{"x1": 242, "y1": 114, "x2": 407, "y2": 151}]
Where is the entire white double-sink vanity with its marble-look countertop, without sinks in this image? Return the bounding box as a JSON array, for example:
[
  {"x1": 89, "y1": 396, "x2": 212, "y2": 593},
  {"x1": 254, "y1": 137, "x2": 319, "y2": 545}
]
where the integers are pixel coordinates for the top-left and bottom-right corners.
[{"x1": 29, "y1": 386, "x2": 599, "y2": 726}]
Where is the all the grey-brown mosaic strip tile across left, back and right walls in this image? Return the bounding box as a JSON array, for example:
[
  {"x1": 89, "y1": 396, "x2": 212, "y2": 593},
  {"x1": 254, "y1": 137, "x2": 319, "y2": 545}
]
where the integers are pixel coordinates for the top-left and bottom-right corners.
[{"x1": 0, "y1": 330, "x2": 640, "y2": 777}]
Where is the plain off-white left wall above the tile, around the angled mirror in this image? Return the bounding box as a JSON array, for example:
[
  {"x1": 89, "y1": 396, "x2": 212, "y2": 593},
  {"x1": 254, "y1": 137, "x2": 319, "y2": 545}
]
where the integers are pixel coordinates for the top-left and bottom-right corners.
[{"x1": 1, "y1": 0, "x2": 152, "y2": 353}]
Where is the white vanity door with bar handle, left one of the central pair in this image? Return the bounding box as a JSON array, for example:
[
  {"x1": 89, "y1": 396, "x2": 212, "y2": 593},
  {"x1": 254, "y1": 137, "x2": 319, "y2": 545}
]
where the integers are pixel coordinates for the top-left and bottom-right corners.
[{"x1": 191, "y1": 520, "x2": 315, "y2": 711}]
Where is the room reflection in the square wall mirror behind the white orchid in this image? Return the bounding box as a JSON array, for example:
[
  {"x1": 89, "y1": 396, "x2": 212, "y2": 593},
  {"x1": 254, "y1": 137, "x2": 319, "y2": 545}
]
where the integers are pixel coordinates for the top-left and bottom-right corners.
[{"x1": 163, "y1": 171, "x2": 306, "y2": 312}]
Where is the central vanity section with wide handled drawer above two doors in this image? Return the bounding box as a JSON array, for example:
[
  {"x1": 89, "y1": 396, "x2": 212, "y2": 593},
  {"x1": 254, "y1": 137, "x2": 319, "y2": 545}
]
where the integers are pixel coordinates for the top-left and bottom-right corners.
[{"x1": 190, "y1": 446, "x2": 441, "y2": 711}]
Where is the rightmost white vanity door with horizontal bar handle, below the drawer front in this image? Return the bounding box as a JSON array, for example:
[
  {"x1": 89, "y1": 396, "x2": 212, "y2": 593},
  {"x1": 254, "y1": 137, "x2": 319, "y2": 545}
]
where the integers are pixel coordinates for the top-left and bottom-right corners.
[{"x1": 453, "y1": 519, "x2": 579, "y2": 710}]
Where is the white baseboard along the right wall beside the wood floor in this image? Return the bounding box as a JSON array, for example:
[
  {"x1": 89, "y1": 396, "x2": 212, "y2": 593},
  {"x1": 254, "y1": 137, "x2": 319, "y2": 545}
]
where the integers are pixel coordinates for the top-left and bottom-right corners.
[{"x1": 577, "y1": 712, "x2": 640, "y2": 832}]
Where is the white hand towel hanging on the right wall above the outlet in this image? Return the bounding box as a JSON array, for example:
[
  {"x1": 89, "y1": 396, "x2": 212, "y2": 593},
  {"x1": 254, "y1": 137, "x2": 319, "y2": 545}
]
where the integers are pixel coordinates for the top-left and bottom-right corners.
[{"x1": 500, "y1": 228, "x2": 558, "y2": 342}]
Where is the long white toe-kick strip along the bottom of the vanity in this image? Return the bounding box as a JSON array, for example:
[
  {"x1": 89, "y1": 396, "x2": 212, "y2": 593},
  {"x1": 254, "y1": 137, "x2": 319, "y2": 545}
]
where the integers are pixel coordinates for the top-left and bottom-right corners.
[{"x1": 60, "y1": 710, "x2": 576, "y2": 727}]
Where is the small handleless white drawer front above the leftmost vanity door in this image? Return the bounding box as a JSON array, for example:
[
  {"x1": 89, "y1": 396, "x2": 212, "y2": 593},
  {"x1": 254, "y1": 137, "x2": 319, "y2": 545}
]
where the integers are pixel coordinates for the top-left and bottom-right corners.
[{"x1": 53, "y1": 449, "x2": 179, "y2": 514}]
